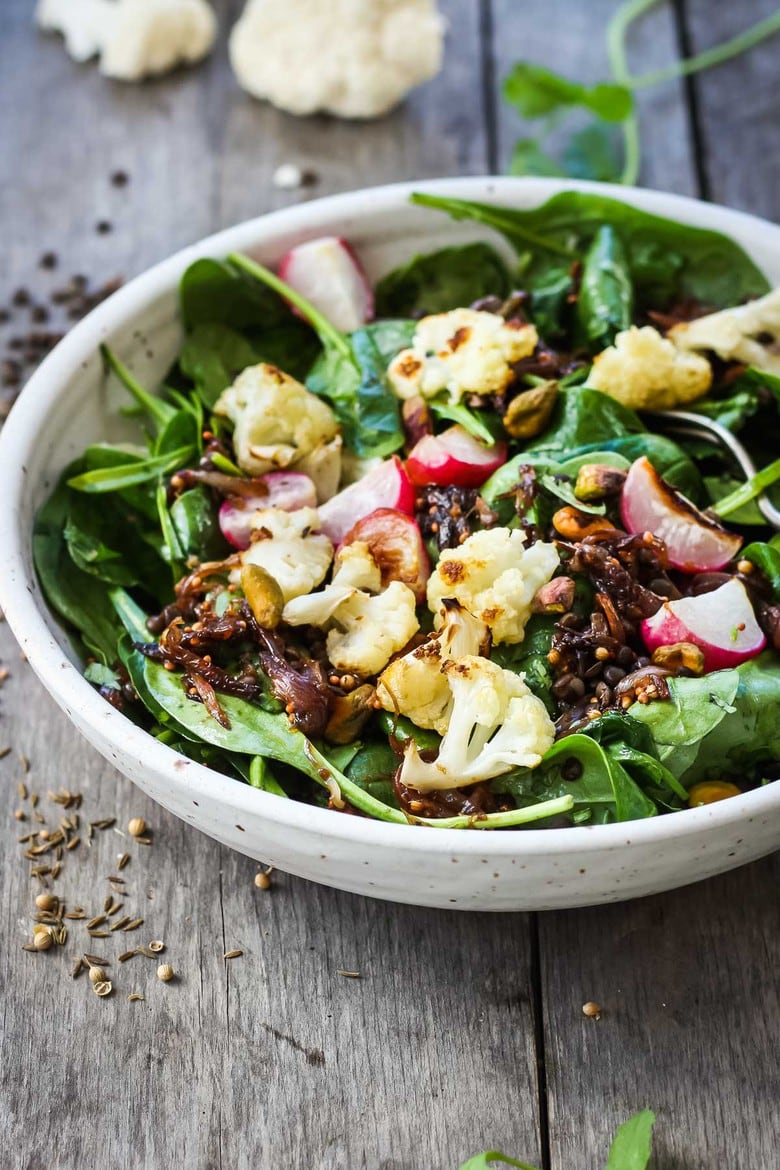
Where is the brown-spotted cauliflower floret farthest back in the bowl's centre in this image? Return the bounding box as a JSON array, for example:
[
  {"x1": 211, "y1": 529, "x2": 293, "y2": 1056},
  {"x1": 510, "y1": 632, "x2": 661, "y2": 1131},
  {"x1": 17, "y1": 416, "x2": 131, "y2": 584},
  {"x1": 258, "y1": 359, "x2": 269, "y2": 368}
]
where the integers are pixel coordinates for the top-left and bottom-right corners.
[{"x1": 387, "y1": 309, "x2": 538, "y2": 402}]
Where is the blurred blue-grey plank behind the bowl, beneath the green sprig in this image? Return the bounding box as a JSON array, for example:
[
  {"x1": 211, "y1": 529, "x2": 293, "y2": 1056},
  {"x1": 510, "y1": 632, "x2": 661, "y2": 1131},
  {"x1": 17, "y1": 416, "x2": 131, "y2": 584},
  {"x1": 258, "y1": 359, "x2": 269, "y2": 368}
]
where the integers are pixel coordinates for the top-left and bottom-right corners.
[{"x1": 492, "y1": 0, "x2": 696, "y2": 195}]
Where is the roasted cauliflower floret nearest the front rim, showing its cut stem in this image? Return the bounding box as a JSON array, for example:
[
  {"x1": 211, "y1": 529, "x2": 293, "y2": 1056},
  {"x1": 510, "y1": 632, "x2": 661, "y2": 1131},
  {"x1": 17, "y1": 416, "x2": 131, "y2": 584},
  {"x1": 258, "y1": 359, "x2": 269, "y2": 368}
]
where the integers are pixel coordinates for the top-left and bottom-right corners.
[{"x1": 401, "y1": 655, "x2": 555, "y2": 792}]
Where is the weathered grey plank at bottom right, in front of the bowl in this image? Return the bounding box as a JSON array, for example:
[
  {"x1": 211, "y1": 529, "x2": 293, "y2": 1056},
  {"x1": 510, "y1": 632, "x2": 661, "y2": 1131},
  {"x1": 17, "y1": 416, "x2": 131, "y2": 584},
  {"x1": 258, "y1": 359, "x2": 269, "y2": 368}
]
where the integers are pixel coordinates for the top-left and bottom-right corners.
[{"x1": 539, "y1": 855, "x2": 780, "y2": 1170}]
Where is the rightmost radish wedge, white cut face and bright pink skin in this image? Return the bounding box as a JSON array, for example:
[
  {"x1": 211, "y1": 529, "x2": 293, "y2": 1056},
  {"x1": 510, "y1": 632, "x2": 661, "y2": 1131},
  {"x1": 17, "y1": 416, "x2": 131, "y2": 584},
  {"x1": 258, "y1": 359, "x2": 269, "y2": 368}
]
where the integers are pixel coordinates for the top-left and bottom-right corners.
[{"x1": 642, "y1": 577, "x2": 766, "y2": 673}]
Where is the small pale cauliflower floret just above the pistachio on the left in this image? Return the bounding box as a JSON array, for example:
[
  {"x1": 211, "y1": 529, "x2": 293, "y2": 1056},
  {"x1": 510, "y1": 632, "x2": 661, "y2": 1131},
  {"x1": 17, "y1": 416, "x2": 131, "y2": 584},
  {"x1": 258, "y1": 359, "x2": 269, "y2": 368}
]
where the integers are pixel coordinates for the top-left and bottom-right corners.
[{"x1": 241, "y1": 508, "x2": 333, "y2": 601}]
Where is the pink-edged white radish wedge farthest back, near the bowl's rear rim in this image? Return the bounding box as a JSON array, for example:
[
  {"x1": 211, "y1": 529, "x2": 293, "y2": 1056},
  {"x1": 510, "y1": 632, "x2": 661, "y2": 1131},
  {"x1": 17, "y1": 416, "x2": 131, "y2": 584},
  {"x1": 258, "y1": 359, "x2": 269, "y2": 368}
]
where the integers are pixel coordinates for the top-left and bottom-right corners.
[{"x1": 279, "y1": 235, "x2": 374, "y2": 333}]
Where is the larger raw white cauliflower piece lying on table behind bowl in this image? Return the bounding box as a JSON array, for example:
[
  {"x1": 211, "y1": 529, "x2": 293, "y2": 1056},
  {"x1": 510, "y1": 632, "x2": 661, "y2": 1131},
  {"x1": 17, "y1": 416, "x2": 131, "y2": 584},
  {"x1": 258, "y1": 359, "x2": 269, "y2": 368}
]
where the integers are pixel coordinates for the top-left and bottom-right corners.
[{"x1": 229, "y1": 0, "x2": 444, "y2": 118}]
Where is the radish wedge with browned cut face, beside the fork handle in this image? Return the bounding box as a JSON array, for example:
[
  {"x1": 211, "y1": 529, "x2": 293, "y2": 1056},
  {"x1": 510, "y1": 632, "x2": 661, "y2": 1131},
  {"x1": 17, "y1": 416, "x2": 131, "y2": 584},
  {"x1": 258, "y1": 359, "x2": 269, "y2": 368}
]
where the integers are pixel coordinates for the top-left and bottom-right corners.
[{"x1": 620, "y1": 455, "x2": 743, "y2": 573}]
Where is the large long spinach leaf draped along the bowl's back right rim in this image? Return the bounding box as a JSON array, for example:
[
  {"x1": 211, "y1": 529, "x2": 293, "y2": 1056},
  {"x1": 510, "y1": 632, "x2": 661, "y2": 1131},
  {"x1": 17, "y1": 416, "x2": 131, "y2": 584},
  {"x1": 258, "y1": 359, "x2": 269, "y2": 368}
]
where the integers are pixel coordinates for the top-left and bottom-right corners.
[{"x1": 412, "y1": 191, "x2": 769, "y2": 322}]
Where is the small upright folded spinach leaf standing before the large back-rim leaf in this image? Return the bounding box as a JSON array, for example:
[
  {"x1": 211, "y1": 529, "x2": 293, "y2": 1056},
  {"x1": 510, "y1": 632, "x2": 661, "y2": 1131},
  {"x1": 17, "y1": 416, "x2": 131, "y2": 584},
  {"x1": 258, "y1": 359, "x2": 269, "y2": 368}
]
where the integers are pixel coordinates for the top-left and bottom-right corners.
[{"x1": 577, "y1": 225, "x2": 634, "y2": 353}]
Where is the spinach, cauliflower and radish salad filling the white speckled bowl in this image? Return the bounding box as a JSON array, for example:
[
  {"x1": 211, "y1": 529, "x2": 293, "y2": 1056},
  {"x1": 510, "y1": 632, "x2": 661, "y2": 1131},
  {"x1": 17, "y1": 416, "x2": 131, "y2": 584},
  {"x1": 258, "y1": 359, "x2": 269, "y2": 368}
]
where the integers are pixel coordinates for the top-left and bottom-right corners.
[{"x1": 34, "y1": 191, "x2": 780, "y2": 830}]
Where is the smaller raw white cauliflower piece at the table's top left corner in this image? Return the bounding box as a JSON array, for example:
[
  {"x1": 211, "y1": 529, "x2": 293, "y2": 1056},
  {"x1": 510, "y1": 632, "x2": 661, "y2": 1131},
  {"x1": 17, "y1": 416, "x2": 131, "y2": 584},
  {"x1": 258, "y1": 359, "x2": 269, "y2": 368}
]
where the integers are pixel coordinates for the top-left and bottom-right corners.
[{"x1": 36, "y1": 0, "x2": 216, "y2": 81}]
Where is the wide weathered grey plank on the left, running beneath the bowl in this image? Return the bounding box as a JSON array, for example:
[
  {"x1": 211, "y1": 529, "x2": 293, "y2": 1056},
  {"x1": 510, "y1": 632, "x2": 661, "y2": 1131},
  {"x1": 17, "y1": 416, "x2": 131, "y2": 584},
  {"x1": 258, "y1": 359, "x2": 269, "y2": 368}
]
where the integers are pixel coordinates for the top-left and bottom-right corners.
[{"x1": 0, "y1": 0, "x2": 541, "y2": 1170}]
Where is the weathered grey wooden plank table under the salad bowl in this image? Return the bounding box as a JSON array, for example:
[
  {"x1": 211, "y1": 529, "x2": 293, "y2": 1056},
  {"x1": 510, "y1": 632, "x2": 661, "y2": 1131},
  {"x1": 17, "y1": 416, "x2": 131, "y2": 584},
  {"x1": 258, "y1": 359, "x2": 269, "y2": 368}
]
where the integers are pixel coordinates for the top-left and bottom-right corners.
[{"x1": 0, "y1": 0, "x2": 780, "y2": 1170}]
